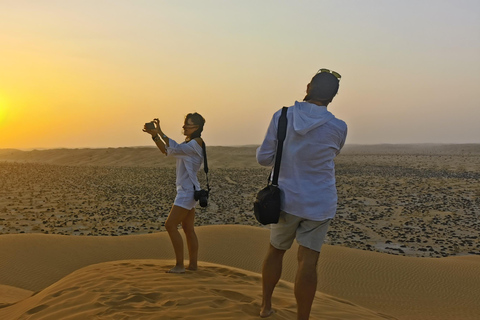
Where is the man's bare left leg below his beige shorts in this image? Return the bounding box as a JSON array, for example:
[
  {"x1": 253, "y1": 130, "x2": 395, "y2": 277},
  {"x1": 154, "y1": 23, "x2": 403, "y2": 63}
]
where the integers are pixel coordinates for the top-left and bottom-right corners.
[{"x1": 260, "y1": 245, "x2": 285, "y2": 318}]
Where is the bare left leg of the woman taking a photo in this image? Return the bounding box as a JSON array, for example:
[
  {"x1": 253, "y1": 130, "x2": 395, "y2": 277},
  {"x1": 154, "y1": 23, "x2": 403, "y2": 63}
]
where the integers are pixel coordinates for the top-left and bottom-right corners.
[{"x1": 165, "y1": 205, "x2": 190, "y2": 273}]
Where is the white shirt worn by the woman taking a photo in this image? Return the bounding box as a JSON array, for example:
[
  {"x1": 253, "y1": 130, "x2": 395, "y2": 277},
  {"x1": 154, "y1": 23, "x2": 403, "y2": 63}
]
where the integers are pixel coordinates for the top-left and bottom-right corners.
[{"x1": 167, "y1": 138, "x2": 203, "y2": 191}]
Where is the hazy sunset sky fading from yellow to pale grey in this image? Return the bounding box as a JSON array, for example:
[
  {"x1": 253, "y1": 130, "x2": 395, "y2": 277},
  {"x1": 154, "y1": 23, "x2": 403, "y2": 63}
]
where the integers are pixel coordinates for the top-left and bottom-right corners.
[{"x1": 0, "y1": 0, "x2": 480, "y2": 148}]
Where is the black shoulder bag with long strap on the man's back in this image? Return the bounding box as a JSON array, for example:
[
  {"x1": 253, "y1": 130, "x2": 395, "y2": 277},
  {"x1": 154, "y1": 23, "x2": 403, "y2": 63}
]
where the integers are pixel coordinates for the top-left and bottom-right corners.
[{"x1": 253, "y1": 107, "x2": 288, "y2": 225}]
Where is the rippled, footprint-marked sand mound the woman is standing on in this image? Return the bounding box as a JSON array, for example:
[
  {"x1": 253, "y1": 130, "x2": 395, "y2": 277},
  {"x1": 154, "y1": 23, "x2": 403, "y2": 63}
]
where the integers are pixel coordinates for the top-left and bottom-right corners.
[{"x1": 0, "y1": 260, "x2": 388, "y2": 319}]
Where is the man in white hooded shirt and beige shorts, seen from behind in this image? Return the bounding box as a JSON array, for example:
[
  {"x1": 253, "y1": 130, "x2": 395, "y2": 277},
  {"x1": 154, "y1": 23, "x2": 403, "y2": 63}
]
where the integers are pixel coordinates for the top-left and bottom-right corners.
[{"x1": 257, "y1": 69, "x2": 347, "y2": 319}]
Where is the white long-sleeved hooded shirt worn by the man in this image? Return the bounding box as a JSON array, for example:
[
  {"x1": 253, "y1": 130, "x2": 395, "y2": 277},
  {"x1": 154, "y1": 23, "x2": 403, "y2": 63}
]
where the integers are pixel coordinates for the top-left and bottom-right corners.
[{"x1": 257, "y1": 101, "x2": 347, "y2": 221}]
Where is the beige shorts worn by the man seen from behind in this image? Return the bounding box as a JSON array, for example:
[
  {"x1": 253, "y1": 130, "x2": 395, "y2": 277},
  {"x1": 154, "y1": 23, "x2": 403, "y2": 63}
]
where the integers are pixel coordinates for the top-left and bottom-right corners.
[{"x1": 270, "y1": 211, "x2": 331, "y2": 252}]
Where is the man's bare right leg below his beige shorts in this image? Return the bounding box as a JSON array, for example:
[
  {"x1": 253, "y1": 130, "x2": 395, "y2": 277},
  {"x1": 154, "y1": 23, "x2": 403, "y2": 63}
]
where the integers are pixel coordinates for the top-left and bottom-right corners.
[{"x1": 295, "y1": 245, "x2": 320, "y2": 320}]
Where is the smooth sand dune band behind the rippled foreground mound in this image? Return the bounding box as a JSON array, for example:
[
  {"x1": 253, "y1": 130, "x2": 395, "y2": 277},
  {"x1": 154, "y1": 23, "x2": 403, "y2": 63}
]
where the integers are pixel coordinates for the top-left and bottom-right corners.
[{"x1": 0, "y1": 226, "x2": 480, "y2": 319}]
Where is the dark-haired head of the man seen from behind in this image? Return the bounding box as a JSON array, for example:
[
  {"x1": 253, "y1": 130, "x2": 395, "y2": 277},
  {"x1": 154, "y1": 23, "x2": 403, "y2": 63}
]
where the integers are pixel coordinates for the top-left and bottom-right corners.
[{"x1": 303, "y1": 72, "x2": 339, "y2": 104}]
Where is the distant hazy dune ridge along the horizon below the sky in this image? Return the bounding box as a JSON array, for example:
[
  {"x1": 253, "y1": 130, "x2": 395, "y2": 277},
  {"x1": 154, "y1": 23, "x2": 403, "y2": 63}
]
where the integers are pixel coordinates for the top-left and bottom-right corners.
[{"x1": 0, "y1": 144, "x2": 480, "y2": 168}]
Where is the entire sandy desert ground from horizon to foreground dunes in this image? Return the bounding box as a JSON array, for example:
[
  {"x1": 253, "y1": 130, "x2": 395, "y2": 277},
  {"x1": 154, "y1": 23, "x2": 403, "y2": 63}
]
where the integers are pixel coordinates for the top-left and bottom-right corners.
[{"x1": 0, "y1": 144, "x2": 480, "y2": 319}]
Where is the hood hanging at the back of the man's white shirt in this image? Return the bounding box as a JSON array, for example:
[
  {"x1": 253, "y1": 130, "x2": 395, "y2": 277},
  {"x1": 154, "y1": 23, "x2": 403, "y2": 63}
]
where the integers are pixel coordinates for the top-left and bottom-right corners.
[{"x1": 292, "y1": 101, "x2": 334, "y2": 136}]
